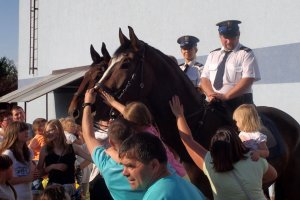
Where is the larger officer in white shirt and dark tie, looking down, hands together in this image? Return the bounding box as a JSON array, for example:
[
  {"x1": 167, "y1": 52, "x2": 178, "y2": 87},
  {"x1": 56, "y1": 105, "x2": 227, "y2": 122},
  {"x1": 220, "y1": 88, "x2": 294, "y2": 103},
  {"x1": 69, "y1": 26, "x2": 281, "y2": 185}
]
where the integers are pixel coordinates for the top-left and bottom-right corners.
[{"x1": 201, "y1": 20, "x2": 260, "y2": 112}]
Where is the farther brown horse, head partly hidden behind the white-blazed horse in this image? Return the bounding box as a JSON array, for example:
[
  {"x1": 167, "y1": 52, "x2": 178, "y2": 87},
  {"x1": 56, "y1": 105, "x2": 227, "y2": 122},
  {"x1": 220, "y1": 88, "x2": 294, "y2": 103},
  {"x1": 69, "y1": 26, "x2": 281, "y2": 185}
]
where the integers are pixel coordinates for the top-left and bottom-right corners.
[{"x1": 68, "y1": 43, "x2": 111, "y2": 124}]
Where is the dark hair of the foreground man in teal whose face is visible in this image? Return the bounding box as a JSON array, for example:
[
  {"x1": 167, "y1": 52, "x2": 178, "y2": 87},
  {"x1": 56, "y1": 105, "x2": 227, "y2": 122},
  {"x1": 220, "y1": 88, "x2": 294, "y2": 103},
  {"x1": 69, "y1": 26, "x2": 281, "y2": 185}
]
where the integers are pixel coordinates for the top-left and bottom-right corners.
[{"x1": 119, "y1": 132, "x2": 167, "y2": 164}]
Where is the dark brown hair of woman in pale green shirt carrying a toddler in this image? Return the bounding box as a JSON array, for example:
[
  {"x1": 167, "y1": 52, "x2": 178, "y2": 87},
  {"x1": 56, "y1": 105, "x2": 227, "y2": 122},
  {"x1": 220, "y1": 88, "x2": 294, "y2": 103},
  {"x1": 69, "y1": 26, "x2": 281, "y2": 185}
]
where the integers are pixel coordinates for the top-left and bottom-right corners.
[{"x1": 210, "y1": 127, "x2": 249, "y2": 172}]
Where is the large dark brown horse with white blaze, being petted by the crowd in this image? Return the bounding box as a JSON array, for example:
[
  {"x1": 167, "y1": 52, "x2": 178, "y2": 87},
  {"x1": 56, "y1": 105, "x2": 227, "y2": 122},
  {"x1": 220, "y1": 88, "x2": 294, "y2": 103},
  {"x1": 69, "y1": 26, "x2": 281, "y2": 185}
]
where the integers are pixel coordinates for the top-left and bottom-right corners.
[{"x1": 74, "y1": 27, "x2": 300, "y2": 199}]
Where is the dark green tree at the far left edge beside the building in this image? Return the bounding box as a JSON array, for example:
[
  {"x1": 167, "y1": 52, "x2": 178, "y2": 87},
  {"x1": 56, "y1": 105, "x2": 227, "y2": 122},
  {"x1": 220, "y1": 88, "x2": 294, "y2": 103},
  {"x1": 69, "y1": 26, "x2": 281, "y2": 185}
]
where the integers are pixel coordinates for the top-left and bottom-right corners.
[{"x1": 0, "y1": 57, "x2": 18, "y2": 97}]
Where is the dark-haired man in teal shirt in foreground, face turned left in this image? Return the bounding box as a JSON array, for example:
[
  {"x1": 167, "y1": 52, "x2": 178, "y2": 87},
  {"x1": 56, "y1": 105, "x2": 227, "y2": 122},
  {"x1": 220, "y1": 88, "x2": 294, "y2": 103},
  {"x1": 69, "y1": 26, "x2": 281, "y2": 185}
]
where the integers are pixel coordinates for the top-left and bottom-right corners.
[{"x1": 119, "y1": 132, "x2": 205, "y2": 200}]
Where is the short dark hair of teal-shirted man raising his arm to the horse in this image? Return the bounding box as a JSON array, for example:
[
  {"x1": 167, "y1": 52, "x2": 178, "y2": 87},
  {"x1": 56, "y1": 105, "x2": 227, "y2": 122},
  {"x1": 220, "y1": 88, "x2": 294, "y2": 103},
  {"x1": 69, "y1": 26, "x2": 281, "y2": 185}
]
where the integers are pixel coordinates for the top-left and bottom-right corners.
[{"x1": 107, "y1": 118, "x2": 132, "y2": 144}]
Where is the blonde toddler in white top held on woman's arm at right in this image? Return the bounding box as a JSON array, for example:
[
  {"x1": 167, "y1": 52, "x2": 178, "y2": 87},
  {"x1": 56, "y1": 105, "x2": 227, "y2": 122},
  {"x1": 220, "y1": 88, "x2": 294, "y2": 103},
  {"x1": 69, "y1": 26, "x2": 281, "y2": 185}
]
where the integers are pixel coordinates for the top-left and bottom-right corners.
[{"x1": 233, "y1": 104, "x2": 275, "y2": 199}]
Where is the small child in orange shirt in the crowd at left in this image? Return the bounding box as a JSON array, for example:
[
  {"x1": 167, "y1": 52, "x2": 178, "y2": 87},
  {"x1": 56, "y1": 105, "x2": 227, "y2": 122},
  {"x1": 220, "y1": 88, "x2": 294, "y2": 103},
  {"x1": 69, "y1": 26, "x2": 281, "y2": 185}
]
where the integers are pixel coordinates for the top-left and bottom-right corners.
[{"x1": 28, "y1": 118, "x2": 47, "y2": 199}]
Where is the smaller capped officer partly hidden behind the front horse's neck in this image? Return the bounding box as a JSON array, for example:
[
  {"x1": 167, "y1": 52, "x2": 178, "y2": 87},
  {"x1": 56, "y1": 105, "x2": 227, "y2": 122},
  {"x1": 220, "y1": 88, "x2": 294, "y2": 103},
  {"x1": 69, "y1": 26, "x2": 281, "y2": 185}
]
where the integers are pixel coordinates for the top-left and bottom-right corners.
[{"x1": 177, "y1": 35, "x2": 203, "y2": 89}]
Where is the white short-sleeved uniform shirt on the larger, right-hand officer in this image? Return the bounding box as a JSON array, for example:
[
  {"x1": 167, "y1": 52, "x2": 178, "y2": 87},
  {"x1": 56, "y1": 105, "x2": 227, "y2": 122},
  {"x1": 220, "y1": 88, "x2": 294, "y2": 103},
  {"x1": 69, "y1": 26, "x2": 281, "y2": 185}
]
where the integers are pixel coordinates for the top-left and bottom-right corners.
[{"x1": 201, "y1": 43, "x2": 260, "y2": 94}]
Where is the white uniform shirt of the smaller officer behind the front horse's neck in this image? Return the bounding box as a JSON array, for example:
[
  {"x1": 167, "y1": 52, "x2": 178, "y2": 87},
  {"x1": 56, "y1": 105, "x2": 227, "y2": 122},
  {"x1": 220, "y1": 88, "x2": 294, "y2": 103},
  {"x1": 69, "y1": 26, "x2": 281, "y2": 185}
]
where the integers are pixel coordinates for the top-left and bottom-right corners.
[{"x1": 179, "y1": 60, "x2": 203, "y2": 87}]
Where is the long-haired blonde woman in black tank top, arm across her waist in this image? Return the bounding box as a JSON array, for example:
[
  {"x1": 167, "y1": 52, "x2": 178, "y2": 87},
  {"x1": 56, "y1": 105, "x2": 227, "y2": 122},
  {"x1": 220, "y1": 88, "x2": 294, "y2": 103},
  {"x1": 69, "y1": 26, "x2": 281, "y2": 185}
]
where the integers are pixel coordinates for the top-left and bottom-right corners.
[{"x1": 37, "y1": 119, "x2": 91, "y2": 199}]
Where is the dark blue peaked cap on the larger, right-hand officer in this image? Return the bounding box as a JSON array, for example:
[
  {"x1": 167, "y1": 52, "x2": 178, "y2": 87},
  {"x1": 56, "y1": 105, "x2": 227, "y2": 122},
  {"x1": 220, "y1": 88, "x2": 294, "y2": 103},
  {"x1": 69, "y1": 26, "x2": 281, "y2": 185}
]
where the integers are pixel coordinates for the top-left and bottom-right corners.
[{"x1": 217, "y1": 20, "x2": 242, "y2": 38}]
